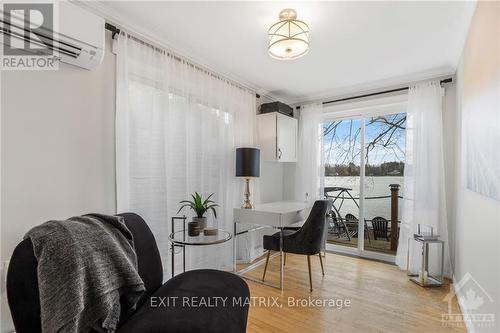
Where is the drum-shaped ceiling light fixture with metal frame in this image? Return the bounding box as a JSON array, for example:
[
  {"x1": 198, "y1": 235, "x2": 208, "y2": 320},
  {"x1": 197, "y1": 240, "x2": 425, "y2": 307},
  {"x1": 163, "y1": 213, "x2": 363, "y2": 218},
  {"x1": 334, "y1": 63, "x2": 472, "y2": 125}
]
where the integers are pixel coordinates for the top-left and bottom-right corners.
[{"x1": 268, "y1": 8, "x2": 309, "y2": 60}]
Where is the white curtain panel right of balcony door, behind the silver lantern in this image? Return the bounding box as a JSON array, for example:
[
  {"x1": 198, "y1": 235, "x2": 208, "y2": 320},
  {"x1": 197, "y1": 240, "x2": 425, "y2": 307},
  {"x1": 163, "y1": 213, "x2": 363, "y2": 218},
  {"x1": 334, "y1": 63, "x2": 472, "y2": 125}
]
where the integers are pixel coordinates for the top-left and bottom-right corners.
[{"x1": 396, "y1": 81, "x2": 451, "y2": 276}]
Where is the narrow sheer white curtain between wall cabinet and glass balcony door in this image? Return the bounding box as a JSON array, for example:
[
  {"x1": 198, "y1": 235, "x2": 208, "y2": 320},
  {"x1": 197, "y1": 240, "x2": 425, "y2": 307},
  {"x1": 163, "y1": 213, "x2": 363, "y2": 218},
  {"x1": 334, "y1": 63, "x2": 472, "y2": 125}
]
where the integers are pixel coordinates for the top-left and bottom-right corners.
[{"x1": 295, "y1": 103, "x2": 324, "y2": 201}]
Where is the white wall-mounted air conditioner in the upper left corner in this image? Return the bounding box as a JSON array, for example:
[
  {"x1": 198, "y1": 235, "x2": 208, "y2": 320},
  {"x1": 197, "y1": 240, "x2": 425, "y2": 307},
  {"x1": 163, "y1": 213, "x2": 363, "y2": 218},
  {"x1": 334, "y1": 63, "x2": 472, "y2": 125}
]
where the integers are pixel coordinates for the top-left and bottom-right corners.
[{"x1": 0, "y1": 1, "x2": 105, "y2": 69}]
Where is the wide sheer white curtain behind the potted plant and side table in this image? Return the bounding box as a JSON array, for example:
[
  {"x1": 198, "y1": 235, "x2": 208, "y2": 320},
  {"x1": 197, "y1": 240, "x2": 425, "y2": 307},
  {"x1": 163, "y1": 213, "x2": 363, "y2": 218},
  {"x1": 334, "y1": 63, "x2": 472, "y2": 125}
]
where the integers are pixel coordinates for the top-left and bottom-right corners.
[{"x1": 114, "y1": 33, "x2": 256, "y2": 278}]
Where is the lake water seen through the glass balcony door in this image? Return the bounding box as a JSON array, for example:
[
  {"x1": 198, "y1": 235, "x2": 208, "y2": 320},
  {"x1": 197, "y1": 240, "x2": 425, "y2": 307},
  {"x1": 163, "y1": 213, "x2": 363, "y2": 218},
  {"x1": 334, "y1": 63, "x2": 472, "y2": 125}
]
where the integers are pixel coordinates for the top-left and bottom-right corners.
[{"x1": 325, "y1": 176, "x2": 404, "y2": 220}]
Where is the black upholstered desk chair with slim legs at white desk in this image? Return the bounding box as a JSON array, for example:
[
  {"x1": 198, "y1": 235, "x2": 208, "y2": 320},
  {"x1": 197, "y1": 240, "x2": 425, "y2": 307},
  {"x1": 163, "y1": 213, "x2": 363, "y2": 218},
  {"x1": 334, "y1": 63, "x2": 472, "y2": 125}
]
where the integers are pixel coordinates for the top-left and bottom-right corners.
[{"x1": 262, "y1": 200, "x2": 329, "y2": 291}]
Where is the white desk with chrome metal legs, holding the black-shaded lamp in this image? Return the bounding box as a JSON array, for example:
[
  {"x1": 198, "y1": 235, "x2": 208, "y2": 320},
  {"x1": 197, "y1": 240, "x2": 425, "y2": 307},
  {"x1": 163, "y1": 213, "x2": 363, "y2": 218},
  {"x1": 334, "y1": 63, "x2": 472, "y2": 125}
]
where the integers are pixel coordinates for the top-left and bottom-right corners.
[{"x1": 233, "y1": 201, "x2": 313, "y2": 289}]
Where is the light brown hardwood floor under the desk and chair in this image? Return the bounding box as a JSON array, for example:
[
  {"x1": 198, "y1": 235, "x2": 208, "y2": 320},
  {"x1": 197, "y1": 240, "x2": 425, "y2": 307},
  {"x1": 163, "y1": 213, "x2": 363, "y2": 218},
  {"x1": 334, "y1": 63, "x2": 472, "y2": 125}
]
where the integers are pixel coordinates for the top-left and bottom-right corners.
[{"x1": 247, "y1": 253, "x2": 466, "y2": 333}]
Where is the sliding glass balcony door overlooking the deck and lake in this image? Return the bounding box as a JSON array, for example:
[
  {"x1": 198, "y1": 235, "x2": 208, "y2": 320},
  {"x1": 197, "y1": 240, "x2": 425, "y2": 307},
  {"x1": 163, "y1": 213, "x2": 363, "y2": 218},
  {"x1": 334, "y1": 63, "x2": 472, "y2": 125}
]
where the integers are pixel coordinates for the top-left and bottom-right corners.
[{"x1": 323, "y1": 110, "x2": 406, "y2": 261}]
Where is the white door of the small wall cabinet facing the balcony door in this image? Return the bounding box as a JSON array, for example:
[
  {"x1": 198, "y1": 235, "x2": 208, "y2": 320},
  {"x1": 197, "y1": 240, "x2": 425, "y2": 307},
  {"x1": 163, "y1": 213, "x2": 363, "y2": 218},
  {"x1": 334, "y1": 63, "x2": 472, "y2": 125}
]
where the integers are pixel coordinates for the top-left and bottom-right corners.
[{"x1": 276, "y1": 113, "x2": 298, "y2": 162}]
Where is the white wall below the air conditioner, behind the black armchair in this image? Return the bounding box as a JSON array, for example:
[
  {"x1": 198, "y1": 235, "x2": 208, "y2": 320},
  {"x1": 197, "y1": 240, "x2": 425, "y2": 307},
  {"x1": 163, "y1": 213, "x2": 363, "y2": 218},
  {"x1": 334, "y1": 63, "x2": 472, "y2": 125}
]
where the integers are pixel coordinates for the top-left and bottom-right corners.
[{"x1": 1, "y1": 32, "x2": 115, "y2": 332}]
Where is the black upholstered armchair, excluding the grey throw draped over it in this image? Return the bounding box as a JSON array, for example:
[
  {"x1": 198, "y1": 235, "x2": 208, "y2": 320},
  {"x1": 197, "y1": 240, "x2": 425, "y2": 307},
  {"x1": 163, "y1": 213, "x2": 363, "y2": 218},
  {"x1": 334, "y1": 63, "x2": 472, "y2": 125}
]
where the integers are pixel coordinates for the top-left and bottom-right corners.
[{"x1": 7, "y1": 213, "x2": 250, "y2": 333}]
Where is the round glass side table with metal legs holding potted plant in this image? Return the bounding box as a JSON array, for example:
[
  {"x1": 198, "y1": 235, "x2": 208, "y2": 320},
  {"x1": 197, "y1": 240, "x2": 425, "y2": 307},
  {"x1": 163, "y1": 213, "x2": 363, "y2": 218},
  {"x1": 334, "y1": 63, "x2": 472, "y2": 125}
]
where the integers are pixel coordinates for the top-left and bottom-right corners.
[{"x1": 168, "y1": 224, "x2": 233, "y2": 277}]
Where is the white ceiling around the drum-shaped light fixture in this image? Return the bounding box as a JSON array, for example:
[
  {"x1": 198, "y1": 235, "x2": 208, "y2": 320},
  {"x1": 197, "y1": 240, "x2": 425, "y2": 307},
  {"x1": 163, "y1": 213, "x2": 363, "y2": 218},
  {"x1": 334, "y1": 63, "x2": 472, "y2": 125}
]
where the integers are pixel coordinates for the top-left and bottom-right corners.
[{"x1": 96, "y1": 1, "x2": 475, "y2": 103}]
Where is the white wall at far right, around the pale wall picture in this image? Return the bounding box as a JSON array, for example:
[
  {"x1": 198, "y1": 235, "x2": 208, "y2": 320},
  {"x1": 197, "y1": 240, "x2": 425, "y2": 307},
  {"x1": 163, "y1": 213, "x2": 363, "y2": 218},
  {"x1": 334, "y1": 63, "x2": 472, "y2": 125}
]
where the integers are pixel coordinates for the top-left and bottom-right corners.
[{"x1": 450, "y1": 2, "x2": 500, "y2": 332}]
